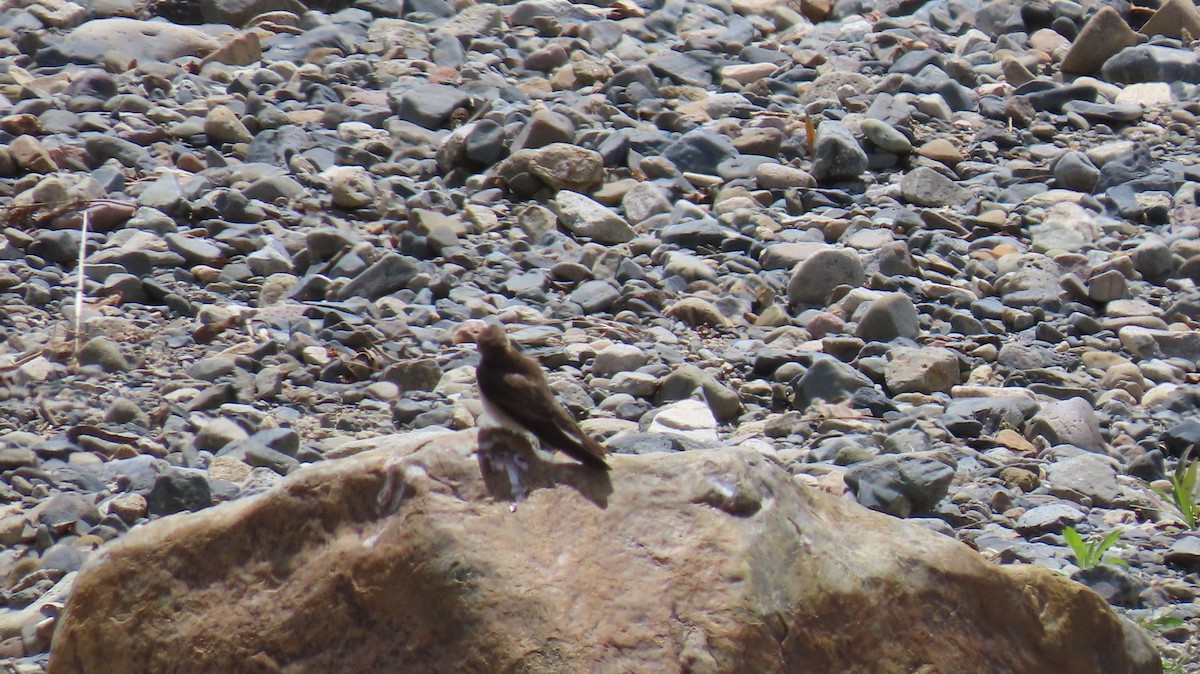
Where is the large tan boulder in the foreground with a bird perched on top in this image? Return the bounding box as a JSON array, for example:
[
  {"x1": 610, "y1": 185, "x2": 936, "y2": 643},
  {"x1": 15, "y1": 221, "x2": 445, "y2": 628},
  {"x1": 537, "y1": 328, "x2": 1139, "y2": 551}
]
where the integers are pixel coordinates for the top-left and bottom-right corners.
[{"x1": 49, "y1": 432, "x2": 1159, "y2": 674}]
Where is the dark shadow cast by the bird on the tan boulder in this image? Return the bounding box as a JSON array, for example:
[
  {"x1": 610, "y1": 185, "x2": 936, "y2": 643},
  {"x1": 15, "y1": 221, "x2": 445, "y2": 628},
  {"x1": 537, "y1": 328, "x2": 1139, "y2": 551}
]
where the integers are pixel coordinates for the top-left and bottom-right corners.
[{"x1": 478, "y1": 428, "x2": 612, "y2": 508}]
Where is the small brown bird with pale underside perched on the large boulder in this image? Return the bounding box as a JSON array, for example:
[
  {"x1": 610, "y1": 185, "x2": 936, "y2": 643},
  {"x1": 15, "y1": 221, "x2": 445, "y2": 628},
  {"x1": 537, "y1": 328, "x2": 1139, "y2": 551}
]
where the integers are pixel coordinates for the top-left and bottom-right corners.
[{"x1": 454, "y1": 320, "x2": 608, "y2": 470}]
